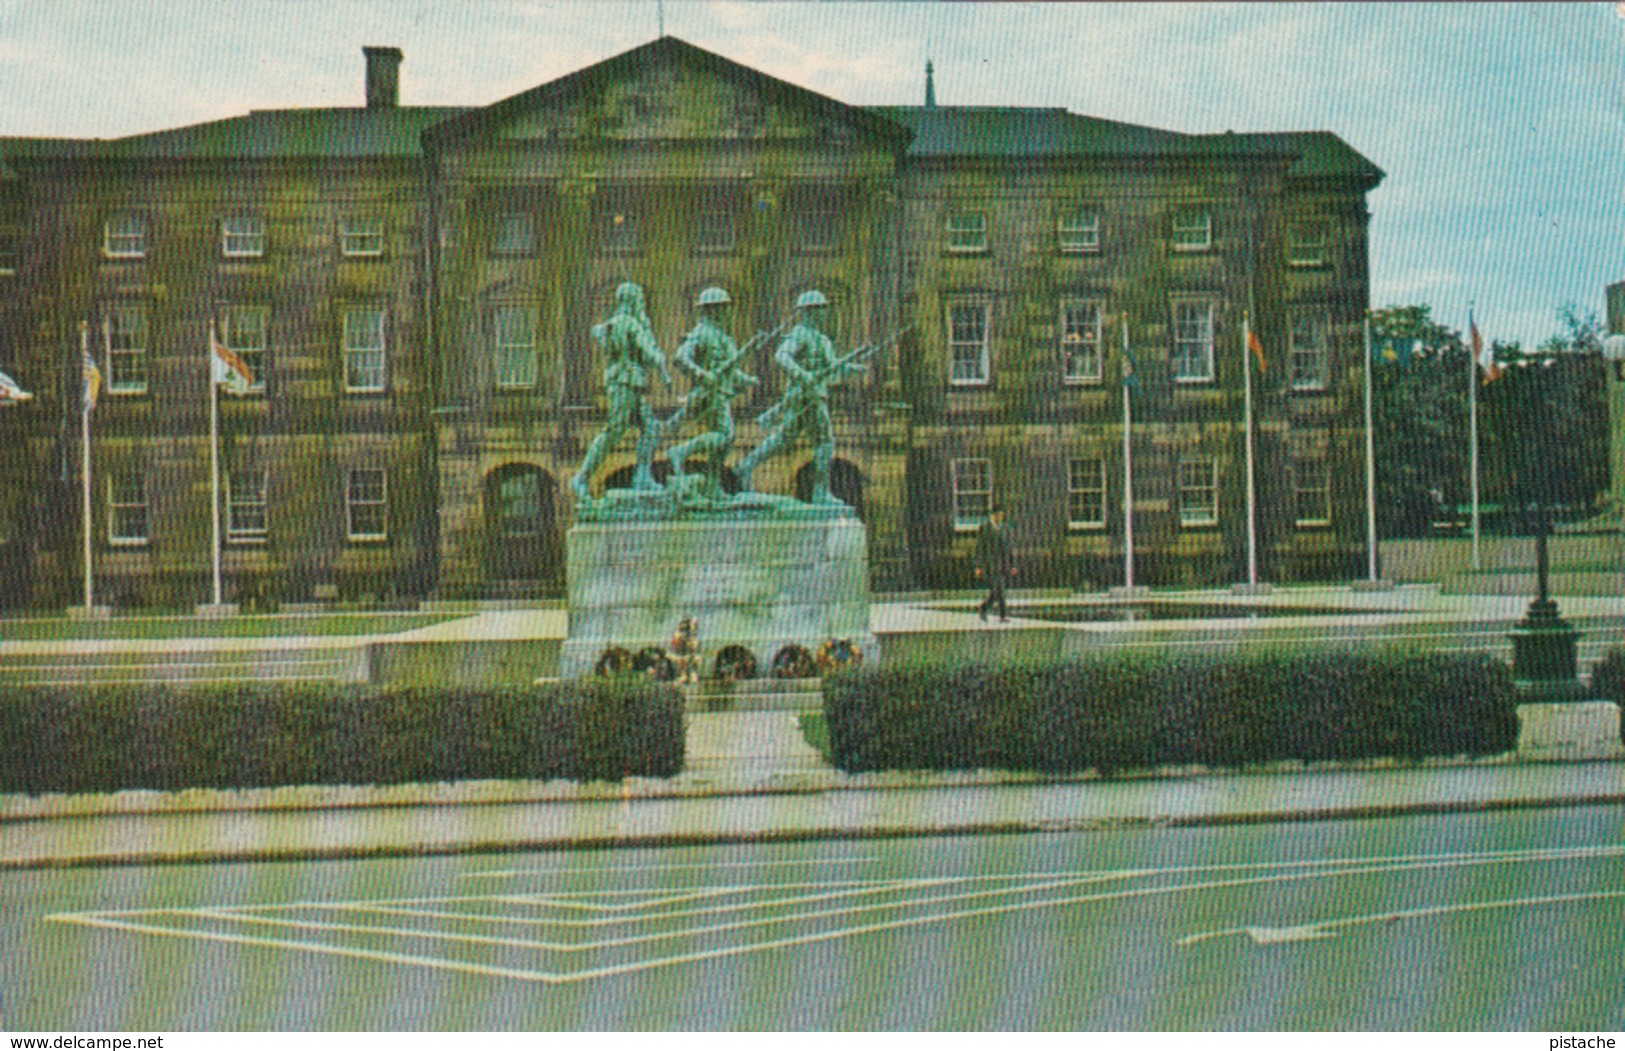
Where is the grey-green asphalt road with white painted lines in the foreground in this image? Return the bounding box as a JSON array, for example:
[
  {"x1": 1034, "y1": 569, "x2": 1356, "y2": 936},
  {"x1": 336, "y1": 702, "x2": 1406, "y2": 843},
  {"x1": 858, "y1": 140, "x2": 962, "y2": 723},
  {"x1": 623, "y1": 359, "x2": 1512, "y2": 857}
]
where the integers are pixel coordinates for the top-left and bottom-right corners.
[{"x1": 0, "y1": 806, "x2": 1625, "y2": 1033}]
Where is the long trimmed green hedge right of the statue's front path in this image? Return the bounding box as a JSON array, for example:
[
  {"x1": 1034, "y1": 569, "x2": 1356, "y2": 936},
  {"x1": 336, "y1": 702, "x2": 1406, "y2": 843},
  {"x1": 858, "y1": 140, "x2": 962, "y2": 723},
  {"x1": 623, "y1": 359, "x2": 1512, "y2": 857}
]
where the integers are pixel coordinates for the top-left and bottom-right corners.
[{"x1": 824, "y1": 653, "x2": 1518, "y2": 773}]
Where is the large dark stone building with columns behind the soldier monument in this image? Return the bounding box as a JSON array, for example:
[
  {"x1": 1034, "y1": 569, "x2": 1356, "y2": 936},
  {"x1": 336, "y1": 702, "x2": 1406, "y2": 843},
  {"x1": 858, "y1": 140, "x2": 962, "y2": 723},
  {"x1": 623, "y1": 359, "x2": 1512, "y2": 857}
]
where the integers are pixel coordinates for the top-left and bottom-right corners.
[{"x1": 0, "y1": 37, "x2": 1381, "y2": 606}]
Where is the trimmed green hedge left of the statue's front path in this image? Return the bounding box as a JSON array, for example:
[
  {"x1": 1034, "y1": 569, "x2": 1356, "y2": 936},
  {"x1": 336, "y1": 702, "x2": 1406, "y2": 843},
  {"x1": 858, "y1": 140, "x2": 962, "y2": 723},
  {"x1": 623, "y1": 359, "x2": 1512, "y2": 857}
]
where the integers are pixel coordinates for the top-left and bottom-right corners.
[{"x1": 0, "y1": 679, "x2": 684, "y2": 794}]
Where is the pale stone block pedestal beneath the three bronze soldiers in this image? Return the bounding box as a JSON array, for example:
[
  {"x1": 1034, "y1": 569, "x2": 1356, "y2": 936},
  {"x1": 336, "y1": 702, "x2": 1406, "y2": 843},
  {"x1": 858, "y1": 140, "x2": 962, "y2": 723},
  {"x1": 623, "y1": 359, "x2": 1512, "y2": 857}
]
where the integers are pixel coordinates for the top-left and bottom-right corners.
[{"x1": 559, "y1": 515, "x2": 879, "y2": 677}]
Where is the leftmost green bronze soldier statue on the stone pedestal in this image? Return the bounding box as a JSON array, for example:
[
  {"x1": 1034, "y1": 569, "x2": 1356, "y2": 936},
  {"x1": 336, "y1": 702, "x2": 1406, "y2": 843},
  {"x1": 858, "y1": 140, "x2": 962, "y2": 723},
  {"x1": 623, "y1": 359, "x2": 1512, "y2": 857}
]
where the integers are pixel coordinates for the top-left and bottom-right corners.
[{"x1": 570, "y1": 281, "x2": 671, "y2": 504}]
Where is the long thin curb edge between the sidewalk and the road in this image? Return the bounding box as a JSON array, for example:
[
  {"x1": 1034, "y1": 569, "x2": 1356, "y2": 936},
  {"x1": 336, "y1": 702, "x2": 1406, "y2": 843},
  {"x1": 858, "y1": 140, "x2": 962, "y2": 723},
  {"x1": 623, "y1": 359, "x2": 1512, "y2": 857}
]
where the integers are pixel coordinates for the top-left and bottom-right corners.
[{"x1": 12, "y1": 793, "x2": 1625, "y2": 872}]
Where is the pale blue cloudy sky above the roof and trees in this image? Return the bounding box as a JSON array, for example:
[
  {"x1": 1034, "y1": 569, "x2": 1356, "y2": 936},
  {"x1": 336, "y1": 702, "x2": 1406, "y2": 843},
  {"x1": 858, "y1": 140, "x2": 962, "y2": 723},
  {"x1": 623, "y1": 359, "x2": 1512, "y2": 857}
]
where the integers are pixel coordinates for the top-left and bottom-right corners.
[{"x1": 0, "y1": 0, "x2": 1625, "y2": 346}]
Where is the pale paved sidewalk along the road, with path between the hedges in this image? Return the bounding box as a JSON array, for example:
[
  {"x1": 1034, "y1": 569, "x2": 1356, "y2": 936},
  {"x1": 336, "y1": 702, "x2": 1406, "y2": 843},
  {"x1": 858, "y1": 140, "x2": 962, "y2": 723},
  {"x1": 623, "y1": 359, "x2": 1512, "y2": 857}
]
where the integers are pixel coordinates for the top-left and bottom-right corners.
[{"x1": 0, "y1": 711, "x2": 1625, "y2": 871}]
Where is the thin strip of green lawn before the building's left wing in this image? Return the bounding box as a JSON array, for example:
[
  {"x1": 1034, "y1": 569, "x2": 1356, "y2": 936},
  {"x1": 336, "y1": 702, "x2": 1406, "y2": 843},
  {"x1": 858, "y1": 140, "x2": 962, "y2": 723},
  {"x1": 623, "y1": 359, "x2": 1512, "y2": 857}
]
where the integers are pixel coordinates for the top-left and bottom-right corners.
[{"x1": 0, "y1": 612, "x2": 468, "y2": 642}]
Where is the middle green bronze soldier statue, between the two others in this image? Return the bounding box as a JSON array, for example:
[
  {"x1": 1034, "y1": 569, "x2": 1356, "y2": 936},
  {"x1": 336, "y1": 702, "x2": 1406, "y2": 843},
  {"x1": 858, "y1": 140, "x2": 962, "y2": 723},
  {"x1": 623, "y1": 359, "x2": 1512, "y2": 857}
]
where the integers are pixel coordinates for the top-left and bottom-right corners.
[{"x1": 661, "y1": 288, "x2": 757, "y2": 500}]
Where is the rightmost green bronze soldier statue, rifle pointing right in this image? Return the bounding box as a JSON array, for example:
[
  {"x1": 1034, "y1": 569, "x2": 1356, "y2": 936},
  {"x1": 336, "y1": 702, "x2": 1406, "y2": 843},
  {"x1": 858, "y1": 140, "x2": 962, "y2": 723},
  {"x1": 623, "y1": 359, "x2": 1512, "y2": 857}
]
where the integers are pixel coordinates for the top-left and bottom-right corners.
[{"x1": 735, "y1": 289, "x2": 873, "y2": 507}]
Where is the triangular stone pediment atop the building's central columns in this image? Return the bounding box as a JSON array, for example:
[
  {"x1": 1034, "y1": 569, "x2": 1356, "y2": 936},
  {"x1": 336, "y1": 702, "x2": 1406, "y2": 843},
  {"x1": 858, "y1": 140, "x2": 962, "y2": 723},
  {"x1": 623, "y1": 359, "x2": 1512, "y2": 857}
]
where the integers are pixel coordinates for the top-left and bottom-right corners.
[{"x1": 426, "y1": 37, "x2": 912, "y2": 149}]
